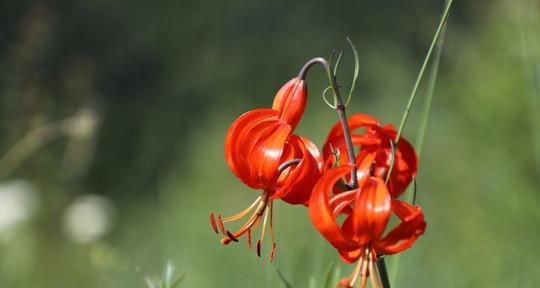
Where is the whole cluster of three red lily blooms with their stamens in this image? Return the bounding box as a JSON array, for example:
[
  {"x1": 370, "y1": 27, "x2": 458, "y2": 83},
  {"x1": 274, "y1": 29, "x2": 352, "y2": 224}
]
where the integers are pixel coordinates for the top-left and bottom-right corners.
[{"x1": 210, "y1": 58, "x2": 426, "y2": 287}]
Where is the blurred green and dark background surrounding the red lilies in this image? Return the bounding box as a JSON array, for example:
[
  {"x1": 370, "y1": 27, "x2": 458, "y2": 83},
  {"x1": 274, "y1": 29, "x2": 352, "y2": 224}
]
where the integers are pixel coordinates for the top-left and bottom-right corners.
[{"x1": 0, "y1": 0, "x2": 540, "y2": 288}]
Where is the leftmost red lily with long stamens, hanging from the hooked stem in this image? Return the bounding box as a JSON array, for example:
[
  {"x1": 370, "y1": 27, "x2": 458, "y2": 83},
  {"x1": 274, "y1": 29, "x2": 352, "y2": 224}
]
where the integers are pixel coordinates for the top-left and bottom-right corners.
[{"x1": 210, "y1": 78, "x2": 323, "y2": 260}]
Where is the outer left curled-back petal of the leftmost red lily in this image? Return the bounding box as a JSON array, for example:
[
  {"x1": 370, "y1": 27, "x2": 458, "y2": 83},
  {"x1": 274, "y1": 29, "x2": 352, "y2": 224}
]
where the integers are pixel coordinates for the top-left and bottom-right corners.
[{"x1": 225, "y1": 109, "x2": 279, "y2": 186}]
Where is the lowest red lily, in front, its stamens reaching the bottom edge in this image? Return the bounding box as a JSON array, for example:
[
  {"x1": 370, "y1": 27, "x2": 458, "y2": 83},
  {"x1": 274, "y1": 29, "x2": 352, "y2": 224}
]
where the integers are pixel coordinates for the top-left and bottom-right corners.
[{"x1": 309, "y1": 163, "x2": 426, "y2": 288}]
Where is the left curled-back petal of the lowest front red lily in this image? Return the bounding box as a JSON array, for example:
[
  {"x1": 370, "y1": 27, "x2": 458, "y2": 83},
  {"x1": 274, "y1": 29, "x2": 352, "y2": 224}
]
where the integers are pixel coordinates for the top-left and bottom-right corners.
[{"x1": 309, "y1": 166, "x2": 358, "y2": 251}]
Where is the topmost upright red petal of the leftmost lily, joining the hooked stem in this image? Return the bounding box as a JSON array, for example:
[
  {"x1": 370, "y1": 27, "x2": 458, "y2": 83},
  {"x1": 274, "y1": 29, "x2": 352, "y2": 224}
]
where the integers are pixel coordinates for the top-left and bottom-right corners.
[{"x1": 272, "y1": 78, "x2": 307, "y2": 130}]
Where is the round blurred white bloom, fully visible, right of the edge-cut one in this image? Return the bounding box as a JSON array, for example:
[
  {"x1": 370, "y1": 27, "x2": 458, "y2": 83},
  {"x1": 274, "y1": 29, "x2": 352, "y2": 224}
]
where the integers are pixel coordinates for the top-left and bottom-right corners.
[{"x1": 63, "y1": 194, "x2": 114, "y2": 243}]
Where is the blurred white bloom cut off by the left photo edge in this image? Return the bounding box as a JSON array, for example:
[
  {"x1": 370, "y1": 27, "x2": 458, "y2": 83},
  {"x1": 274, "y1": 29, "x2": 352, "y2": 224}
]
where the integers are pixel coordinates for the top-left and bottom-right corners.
[{"x1": 0, "y1": 180, "x2": 38, "y2": 233}]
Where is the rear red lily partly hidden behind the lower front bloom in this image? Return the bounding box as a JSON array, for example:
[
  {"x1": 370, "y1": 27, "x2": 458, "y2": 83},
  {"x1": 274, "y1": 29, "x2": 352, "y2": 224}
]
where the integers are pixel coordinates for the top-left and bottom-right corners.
[{"x1": 323, "y1": 113, "x2": 418, "y2": 198}]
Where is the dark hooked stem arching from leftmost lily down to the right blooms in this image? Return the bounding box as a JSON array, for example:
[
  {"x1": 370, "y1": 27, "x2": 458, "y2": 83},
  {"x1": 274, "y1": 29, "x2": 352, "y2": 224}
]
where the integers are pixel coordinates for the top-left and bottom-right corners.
[{"x1": 298, "y1": 57, "x2": 358, "y2": 189}]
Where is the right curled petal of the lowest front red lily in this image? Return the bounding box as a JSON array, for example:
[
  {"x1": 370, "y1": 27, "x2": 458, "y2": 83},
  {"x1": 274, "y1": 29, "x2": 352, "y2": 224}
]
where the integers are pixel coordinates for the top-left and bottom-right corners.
[{"x1": 375, "y1": 200, "x2": 426, "y2": 255}]
